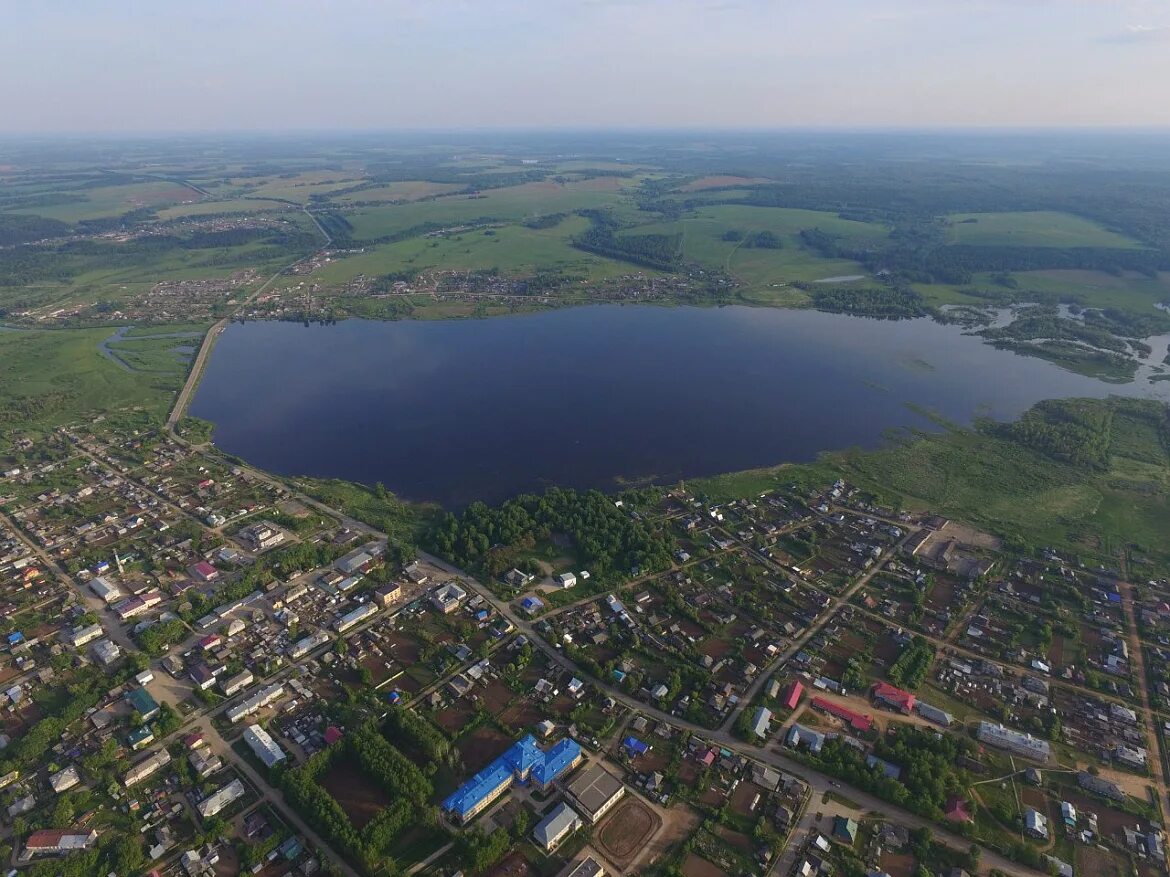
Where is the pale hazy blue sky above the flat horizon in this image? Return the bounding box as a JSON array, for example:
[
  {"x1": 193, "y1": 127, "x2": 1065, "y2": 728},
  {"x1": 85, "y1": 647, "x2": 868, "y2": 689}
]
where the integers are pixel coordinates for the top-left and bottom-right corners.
[{"x1": 0, "y1": 0, "x2": 1170, "y2": 133}]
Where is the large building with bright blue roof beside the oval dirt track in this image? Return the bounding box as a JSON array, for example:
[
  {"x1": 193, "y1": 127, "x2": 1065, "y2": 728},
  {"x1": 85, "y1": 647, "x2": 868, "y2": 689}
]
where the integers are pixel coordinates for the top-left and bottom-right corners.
[{"x1": 442, "y1": 734, "x2": 581, "y2": 824}]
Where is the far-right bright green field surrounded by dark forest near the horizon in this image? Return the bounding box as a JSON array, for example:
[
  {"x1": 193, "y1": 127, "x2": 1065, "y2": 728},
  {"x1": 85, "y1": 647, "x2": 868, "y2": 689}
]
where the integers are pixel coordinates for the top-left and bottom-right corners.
[{"x1": 948, "y1": 210, "x2": 1141, "y2": 249}]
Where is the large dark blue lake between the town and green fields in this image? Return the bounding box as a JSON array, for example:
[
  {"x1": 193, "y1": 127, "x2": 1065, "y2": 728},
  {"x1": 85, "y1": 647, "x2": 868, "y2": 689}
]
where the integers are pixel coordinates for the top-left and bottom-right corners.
[{"x1": 191, "y1": 305, "x2": 1170, "y2": 506}]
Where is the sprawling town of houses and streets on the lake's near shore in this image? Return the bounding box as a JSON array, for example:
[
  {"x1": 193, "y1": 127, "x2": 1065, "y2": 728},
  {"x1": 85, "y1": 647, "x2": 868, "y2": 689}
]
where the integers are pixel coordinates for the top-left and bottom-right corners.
[{"x1": 0, "y1": 419, "x2": 1170, "y2": 877}]
